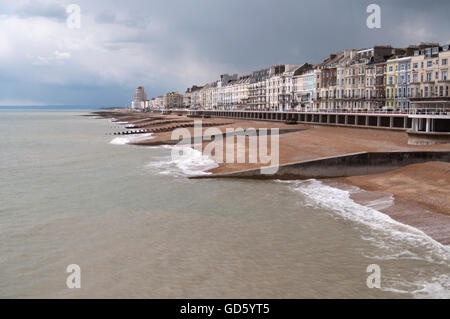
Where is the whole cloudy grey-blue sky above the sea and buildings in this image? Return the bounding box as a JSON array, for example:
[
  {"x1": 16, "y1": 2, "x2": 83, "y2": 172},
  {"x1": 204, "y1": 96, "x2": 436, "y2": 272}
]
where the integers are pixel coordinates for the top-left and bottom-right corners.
[{"x1": 0, "y1": 0, "x2": 450, "y2": 106}]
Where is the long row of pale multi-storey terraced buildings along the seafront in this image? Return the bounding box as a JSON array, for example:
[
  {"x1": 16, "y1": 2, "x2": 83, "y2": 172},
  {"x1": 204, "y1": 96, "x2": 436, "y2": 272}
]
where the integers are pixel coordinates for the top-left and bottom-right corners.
[{"x1": 139, "y1": 43, "x2": 450, "y2": 141}]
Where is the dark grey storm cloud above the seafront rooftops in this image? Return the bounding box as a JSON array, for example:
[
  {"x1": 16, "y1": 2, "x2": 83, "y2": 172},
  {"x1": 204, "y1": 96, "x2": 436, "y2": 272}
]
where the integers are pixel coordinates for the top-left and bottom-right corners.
[{"x1": 136, "y1": 0, "x2": 450, "y2": 69}]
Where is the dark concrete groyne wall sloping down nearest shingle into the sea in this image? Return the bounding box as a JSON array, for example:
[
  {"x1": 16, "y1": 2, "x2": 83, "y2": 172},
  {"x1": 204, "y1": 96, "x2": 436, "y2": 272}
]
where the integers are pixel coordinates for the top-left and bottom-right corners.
[{"x1": 191, "y1": 152, "x2": 450, "y2": 179}]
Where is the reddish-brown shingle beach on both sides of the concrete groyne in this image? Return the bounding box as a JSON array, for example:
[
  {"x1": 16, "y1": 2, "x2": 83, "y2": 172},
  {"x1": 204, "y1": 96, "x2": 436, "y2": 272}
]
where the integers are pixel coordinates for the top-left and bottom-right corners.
[{"x1": 95, "y1": 110, "x2": 450, "y2": 245}]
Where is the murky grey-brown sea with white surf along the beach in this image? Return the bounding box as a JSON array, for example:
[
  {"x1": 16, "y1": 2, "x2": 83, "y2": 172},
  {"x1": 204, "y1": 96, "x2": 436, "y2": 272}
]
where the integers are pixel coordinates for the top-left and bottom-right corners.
[{"x1": 0, "y1": 107, "x2": 450, "y2": 298}]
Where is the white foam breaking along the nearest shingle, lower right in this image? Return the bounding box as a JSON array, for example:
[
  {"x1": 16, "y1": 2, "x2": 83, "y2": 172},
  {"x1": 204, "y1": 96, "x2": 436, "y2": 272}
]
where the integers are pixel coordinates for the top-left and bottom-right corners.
[{"x1": 278, "y1": 179, "x2": 450, "y2": 298}]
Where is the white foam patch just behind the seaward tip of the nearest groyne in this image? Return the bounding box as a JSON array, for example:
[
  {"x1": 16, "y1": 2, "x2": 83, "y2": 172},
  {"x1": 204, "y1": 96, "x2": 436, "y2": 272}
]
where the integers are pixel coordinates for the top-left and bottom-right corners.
[{"x1": 146, "y1": 145, "x2": 218, "y2": 176}]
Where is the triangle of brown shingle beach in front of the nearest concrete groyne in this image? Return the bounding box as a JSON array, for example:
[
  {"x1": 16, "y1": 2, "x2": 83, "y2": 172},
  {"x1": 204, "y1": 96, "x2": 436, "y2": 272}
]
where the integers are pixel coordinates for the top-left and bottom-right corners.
[{"x1": 329, "y1": 162, "x2": 450, "y2": 245}]
